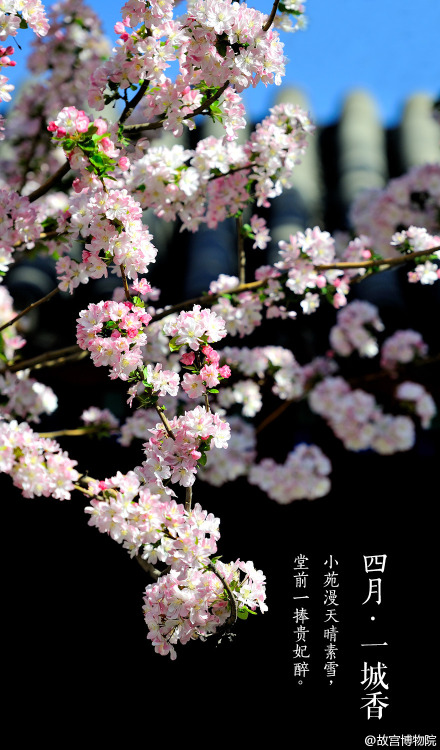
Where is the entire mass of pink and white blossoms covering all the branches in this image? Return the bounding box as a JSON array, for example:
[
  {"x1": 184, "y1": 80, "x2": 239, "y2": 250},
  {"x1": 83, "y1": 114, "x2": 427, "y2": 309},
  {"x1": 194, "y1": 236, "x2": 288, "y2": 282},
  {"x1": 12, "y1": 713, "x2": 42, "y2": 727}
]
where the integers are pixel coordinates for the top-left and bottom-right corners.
[{"x1": 0, "y1": 0, "x2": 440, "y2": 659}]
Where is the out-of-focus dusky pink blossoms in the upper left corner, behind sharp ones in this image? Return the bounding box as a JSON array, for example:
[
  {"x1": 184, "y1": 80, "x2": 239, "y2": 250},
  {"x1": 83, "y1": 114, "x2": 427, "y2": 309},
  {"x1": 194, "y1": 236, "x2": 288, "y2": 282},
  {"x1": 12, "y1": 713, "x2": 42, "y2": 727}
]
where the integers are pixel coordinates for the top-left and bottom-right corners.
[{"x1": 0, "y1": 0, "x2": 110, "y2": 192}]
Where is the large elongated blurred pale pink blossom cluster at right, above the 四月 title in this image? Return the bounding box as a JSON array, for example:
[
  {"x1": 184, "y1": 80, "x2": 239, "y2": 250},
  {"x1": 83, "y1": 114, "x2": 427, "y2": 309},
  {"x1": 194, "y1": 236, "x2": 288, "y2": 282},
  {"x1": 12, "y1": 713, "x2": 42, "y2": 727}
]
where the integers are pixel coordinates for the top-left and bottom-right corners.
[{"x1": 308, "y1": 377, "x2": 415, "y2": 455}]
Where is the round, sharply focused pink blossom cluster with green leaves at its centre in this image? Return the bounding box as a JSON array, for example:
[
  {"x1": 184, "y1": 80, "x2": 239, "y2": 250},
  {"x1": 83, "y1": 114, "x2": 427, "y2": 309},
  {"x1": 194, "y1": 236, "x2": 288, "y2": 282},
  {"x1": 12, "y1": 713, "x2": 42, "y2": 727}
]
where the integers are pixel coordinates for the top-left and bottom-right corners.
[{"x1": 77, "y1": 300, "x2": 151, "y2": 380}]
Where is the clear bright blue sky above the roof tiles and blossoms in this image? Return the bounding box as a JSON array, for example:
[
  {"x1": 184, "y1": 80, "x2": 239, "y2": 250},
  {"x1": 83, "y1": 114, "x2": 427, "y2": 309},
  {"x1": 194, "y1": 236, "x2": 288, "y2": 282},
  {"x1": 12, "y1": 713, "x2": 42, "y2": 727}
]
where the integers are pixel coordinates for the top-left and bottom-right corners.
[{"x1": 4, "y1": 0, "x2": 440, "y2": 126}]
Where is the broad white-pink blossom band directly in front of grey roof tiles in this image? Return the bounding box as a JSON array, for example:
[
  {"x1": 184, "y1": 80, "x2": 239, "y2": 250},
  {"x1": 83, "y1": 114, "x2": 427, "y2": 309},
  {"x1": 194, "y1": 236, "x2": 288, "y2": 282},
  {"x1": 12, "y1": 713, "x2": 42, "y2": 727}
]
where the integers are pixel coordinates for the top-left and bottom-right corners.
[{"x1": 126, "y1": 103, "x2": 313, "y2": 232}]
